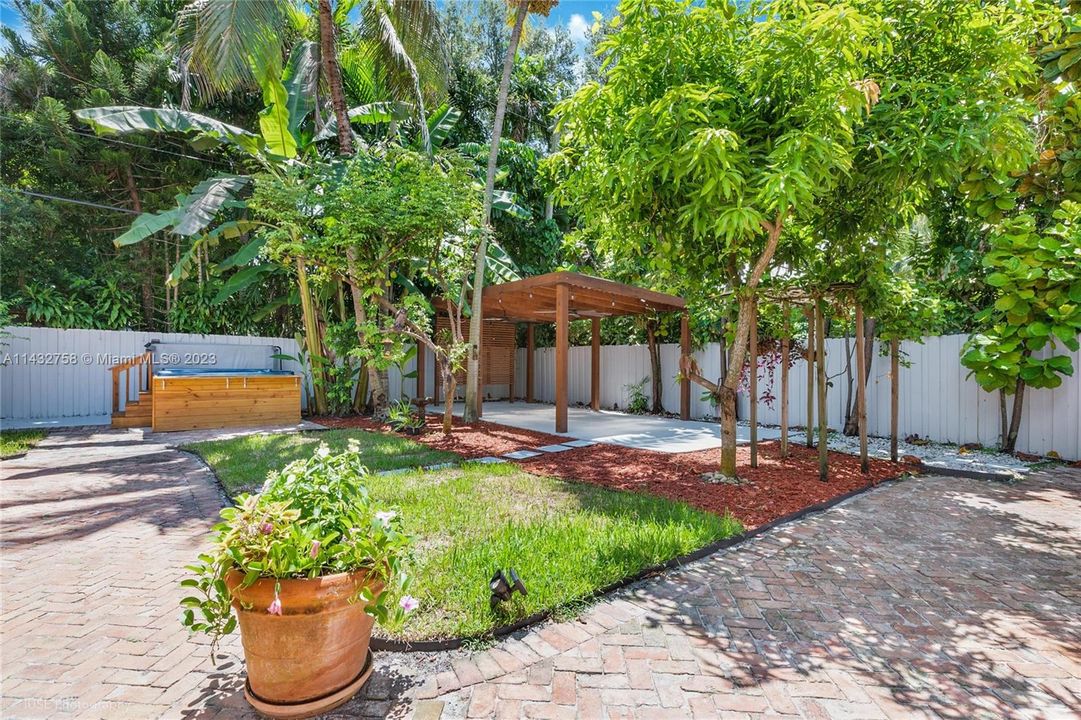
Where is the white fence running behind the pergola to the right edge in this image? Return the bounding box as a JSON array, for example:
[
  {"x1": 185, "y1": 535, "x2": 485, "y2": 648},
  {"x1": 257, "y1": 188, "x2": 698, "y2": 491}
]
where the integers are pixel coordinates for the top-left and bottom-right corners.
[{"x1": 515, "y1": 335, "x2": 1081, "y2": 459}]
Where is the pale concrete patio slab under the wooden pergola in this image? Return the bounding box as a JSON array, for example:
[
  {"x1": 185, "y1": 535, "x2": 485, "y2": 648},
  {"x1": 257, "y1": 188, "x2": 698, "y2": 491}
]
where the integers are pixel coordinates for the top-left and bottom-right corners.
[{"x1": 430, "y1": 402, "x2": 780, "y2": 453}]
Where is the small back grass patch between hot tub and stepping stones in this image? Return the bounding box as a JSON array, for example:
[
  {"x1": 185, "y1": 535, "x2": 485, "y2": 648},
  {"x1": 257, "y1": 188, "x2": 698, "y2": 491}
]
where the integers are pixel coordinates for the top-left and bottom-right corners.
[{"x1": 185, "y1": 430, "x2": 458, "y2": 496}]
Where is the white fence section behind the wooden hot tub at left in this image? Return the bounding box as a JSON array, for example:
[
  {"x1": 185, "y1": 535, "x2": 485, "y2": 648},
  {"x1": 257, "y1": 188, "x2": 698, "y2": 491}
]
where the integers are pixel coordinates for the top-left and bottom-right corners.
[{"x1": 0, "y1": 326, "x2": 307, "y2": 425}]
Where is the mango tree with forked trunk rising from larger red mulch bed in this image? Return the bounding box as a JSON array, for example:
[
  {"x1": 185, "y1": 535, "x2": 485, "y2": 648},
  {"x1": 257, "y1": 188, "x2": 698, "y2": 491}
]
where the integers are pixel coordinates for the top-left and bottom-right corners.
[{"x1": 550, "y1": 0, "x2": 1025, "y2": 475}]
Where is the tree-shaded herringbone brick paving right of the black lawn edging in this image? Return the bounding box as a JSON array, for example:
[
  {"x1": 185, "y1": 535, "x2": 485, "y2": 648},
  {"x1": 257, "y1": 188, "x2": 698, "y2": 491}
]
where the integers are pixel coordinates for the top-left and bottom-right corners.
[{"x1": 413, "y1": 469, "x2": 1081, "y2": 720}]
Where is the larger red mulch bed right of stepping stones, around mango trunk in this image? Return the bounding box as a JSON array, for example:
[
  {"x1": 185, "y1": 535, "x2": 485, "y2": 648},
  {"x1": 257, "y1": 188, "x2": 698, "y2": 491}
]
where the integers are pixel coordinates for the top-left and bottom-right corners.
[{"x1": 522, "y1": 441, "x2": 911, "y2": 529}]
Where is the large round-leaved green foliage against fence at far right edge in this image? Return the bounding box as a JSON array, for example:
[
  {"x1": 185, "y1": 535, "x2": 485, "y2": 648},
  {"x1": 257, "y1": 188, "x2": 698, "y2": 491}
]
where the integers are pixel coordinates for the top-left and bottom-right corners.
[{"x1": 961, "y1": 201, "x2": 1081, "y2": 394}]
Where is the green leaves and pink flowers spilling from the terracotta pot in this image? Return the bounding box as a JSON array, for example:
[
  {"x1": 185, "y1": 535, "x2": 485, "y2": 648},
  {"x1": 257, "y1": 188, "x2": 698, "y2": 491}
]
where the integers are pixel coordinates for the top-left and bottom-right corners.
[{"x1": 181, "y1": 444, "x2": 410, "y2": 641}]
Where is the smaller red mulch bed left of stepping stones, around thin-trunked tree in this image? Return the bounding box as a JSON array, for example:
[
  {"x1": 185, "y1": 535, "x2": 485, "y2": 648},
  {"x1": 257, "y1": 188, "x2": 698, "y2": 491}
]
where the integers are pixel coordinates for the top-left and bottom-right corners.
[{"x1": 311, "y1": 415, "x2": 566, "y2": 459}]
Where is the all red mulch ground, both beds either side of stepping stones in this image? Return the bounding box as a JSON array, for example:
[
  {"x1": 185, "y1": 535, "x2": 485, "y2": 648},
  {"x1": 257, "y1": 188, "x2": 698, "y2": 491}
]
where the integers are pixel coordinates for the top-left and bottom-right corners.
[{"x1": 311, "y1": 416, "x2": 911, "y2": 529}]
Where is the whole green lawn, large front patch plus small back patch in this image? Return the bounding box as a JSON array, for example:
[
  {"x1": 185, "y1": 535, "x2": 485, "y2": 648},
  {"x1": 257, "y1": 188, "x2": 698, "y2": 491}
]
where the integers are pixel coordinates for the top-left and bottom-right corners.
[{"x1": 188, "y1": 432, "x2": 743, "y2": 640}]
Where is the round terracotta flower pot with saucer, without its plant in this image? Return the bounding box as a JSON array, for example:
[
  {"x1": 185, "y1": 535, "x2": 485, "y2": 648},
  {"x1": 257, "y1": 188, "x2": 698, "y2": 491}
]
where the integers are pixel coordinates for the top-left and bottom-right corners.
[{"x1": 225, "y1": 570, "x2": 383, "y2": 718}]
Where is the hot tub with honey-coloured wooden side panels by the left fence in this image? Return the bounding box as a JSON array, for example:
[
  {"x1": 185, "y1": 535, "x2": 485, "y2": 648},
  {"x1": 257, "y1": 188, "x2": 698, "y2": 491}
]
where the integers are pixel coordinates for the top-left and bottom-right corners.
[{"x1": 150, "y1": 368, "x2": 301, "y2": 432}]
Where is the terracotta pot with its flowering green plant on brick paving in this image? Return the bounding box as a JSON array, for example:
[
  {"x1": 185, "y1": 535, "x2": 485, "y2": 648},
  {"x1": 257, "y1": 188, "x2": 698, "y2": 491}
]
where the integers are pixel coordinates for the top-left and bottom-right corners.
[{"x1": 182, "y1": 443, "x2": 416, "y2": 718}]
